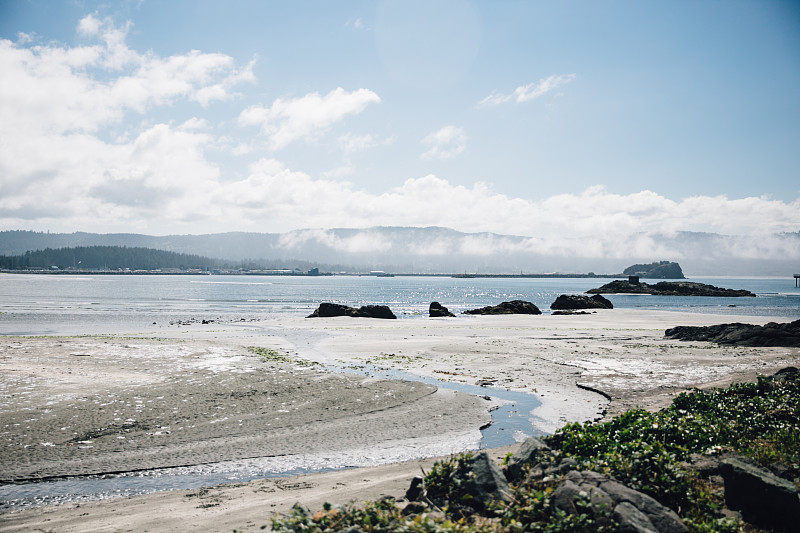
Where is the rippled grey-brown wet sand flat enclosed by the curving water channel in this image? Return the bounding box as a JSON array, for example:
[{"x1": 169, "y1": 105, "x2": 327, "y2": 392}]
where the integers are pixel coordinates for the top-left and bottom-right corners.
[{"x1": 0, "y1": 337, "x2": 490, "y2": 482}]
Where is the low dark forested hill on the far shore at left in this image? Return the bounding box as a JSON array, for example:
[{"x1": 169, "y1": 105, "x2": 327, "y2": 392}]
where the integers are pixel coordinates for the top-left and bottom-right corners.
[{"x1": 0, "y1": 246, "x2": 220, "y2": 270}]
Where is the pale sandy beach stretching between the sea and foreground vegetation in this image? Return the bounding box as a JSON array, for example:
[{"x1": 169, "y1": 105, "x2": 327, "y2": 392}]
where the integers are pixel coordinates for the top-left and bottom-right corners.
[{"x1": 0, "y1": 309, "x2": 800, "y2": 531}]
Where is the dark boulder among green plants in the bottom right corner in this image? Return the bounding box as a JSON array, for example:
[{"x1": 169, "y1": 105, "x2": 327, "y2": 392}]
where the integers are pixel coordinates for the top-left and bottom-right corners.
[{"x1": 720, "y1": 457, "x2": 800, "y2": 531}]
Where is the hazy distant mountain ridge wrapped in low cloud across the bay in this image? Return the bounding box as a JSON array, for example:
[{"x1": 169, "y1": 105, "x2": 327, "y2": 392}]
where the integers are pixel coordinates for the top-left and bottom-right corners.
[{"x1": 0, "y1": 227, "x2": 800, "y2": 277}]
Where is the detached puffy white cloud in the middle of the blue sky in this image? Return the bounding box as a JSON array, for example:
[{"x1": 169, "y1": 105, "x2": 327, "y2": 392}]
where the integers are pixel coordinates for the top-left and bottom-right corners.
[{"x1": 239, "y1": 87, "x2": 381, "y2": 150}]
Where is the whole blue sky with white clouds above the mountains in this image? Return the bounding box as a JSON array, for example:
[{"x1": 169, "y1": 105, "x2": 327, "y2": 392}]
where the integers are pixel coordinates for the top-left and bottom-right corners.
[{"x1": 0, "y1": 0, "x2": 800, "y2": 239}]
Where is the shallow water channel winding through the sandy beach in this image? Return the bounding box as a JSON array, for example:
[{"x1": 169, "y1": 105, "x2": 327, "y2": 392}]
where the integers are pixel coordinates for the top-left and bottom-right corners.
[{"x1": 0, "y1": 365, "x2": 544, "y2": 513}]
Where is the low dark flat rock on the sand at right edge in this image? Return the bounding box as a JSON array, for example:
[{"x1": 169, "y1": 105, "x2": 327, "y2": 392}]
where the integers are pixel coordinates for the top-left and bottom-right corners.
[{"x1": 664, "y1": 320, "x2": 800, "y2": 347}]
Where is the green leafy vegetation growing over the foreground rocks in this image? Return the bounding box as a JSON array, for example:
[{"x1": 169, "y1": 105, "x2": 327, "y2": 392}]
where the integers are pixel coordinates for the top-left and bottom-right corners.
[{"x1": 272, "y1": 375, "x2": 800, "y2": 533}]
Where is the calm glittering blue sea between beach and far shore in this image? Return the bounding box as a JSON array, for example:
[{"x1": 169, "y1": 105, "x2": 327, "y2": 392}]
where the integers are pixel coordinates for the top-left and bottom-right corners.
[{"x1": 0, "y1": 274, "x2": 800, "y2": 335}]
